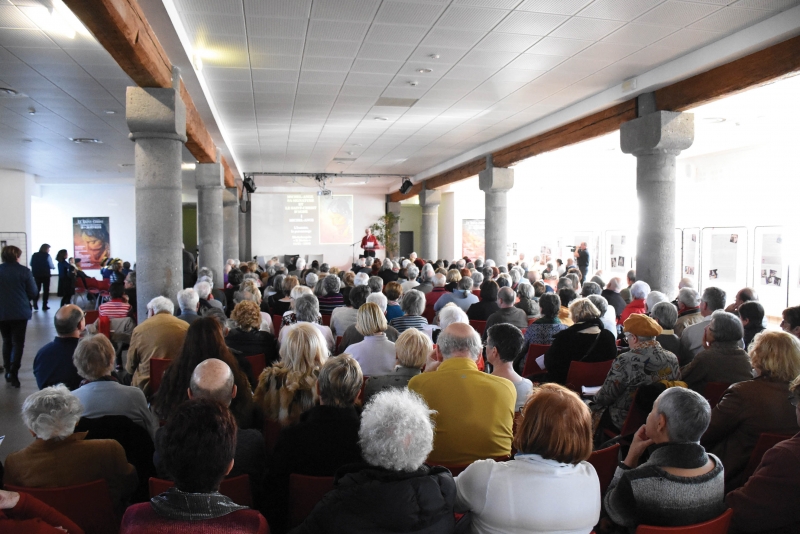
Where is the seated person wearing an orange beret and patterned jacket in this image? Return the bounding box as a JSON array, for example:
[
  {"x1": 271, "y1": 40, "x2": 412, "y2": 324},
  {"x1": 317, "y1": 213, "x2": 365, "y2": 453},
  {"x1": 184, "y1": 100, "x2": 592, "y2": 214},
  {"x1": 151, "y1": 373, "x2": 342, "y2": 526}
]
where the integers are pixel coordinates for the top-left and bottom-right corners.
[{"x1": 589, "y1": 313, "x2": 681, "y2": 431}]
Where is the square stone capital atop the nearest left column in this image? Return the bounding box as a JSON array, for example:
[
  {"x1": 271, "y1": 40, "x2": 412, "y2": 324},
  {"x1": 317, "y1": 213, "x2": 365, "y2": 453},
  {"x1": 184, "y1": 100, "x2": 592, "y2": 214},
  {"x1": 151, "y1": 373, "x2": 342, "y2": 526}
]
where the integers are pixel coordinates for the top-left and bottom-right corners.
[{"x1": 125, "y1": 87, "x2": 186, "y2": 143}]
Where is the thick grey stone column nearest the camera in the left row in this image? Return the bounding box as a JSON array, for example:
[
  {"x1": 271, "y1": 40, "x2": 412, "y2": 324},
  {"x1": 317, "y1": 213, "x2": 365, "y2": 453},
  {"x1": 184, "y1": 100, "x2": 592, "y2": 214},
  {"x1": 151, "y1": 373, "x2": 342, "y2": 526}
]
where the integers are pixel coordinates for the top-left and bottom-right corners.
[{"x1": 125, "y1": 87, "x2": 186, "y2": 314}]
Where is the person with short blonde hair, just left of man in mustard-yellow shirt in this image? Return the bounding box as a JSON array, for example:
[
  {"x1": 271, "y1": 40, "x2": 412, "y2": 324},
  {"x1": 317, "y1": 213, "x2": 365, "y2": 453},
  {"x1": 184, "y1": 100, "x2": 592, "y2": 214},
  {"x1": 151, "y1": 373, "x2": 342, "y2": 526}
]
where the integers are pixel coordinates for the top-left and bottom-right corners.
[{"x1": 364, "y1": 328, "x2": 433, "y2": 403}]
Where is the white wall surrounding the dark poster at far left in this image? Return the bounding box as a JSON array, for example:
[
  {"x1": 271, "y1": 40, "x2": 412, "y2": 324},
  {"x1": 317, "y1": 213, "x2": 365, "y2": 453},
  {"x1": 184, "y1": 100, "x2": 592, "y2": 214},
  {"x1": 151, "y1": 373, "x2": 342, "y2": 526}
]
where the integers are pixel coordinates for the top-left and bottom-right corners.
[{"x1": 31, "y1": 184, "x2": 136, "y2": 276}]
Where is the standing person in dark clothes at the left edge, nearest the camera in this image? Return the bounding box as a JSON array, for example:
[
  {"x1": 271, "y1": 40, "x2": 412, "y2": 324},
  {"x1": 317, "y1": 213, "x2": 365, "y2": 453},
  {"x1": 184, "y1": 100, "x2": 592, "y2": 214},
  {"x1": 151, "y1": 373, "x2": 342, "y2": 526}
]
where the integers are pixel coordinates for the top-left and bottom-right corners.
[{"x1": 0, "y1": 245, "x2": 36, "y2": 388}]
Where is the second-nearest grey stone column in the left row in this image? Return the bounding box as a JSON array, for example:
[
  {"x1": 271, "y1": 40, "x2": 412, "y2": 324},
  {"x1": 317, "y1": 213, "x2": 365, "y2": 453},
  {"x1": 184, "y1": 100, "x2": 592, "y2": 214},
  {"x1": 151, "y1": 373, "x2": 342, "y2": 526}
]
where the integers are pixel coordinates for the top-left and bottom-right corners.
[{"x1": 195, "y1": 163, "x2": 225, "y2": 287}]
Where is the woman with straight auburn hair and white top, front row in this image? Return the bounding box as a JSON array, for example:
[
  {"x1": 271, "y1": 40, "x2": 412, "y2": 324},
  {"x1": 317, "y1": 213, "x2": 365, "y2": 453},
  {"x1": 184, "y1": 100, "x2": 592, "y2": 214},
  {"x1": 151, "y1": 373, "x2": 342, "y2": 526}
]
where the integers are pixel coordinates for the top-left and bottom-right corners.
[{"x1": 456, "y1": 386, "x2": 600, "y2": 534}]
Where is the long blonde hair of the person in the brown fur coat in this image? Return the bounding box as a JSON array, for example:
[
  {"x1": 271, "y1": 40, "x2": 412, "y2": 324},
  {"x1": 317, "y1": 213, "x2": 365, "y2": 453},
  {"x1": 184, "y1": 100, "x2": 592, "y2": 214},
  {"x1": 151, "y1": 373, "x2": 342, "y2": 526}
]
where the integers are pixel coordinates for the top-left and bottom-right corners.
[{"x1": 280, "y1": 323, "x2": 328, "y2": 391}]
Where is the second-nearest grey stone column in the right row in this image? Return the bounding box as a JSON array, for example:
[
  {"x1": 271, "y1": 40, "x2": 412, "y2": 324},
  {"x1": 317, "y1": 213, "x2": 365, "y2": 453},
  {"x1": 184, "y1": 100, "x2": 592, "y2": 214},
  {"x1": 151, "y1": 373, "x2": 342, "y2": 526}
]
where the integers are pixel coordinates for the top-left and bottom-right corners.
[{"x1": 478, "y1": 161, "x2": 514, "y2": 265}]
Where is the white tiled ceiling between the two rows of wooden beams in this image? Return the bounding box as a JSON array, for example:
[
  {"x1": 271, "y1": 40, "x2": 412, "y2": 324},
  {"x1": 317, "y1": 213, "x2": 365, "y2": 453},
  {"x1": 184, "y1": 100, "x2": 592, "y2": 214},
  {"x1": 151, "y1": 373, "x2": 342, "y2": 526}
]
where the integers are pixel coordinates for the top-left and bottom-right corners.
[{"x1": 164, "y1": 0, "x2": 800, "y2": 185}]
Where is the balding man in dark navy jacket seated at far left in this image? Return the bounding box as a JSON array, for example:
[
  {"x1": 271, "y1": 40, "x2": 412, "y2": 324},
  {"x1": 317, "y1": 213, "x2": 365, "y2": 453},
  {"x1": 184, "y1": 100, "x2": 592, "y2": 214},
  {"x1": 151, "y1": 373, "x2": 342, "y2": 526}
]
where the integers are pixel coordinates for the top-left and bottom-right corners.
[{"x1": 33, "y1": 304, "x2": 86, "y2": 391}]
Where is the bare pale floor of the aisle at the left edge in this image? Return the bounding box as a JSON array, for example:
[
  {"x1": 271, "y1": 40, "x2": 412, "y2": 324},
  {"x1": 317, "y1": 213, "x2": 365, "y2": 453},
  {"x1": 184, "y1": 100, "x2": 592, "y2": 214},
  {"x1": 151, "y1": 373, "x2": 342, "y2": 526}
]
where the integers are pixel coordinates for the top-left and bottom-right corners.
[{"x1": 0, "y1": 302, "x2": 60, "y2": 462}]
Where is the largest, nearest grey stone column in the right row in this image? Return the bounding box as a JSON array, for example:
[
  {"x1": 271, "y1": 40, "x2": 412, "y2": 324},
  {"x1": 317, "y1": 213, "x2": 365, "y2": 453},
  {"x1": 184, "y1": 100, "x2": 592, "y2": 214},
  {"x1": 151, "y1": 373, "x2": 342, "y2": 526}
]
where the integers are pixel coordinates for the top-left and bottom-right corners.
[{"x1": 620, "y1": 108, "x2": 694, "y2": 298}]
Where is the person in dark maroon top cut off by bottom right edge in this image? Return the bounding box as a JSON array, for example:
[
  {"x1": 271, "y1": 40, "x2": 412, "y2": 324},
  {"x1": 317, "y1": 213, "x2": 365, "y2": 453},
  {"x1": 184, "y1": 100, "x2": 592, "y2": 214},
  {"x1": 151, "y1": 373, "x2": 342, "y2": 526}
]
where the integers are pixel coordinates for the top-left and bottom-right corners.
[{"x1": 725, "y1": 376, "x2": 800, "y2": 534}]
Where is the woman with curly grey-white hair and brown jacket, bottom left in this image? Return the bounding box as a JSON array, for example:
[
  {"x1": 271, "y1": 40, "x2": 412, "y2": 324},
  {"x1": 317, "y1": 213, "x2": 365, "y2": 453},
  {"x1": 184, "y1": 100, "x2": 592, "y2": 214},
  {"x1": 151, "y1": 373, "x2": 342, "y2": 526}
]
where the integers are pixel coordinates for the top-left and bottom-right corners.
[{"x1": 3, "y1": 384, "x2": 138, "y2": 511}]
